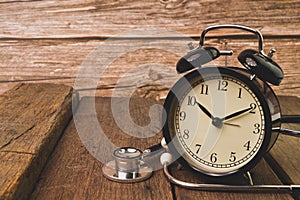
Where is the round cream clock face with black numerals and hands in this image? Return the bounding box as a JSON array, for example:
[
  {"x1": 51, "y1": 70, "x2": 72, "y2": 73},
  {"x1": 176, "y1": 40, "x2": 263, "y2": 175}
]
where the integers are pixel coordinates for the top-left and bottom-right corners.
[{"x1": 164, "y1": 67, "x2": 272, "y2": 175}]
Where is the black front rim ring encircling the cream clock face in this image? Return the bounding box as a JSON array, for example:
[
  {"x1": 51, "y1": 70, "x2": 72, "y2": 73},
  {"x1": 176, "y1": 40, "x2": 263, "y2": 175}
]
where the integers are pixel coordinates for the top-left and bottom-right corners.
[{"x1": 162, "y1": 66, "x2": 277, "y2": 177}]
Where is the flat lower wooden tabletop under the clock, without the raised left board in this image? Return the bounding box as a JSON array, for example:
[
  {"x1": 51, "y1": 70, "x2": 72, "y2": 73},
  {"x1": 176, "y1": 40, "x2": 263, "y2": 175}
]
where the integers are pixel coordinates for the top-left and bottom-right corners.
[{"x1": 31, "y1": 97, "x2": 300, "y2": 200}]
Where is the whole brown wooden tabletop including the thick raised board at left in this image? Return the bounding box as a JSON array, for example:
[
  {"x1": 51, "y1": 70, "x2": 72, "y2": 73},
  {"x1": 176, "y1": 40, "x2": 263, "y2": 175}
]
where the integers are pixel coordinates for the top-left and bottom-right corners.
[{"x1": 0, "y1": 83, "x2": 300, "y2": 200}]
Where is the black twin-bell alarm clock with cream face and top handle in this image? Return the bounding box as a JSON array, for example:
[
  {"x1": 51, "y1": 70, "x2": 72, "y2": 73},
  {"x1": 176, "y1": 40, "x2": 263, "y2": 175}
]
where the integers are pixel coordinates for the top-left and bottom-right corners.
[{"x1": 163, "y1": 25, "x2": 283, "y2": 177}]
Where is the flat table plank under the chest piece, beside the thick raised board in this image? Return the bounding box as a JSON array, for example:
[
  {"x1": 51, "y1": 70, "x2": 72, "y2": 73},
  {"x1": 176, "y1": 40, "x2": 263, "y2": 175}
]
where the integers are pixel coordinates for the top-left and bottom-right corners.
[{"x1": 31, "y1": 98, "x2": 172, "y2": 199}]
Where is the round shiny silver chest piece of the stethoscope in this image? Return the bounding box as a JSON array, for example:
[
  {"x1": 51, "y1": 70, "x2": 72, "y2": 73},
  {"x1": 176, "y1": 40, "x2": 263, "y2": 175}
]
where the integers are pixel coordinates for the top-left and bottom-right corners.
[{"x1": 102, "y1": 147, "x2": 153, "y2": 183}]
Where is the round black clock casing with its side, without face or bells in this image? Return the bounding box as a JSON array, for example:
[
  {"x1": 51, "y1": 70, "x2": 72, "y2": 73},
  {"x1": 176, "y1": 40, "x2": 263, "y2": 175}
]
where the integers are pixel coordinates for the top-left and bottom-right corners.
[{"x1": 163, "y1": 67, "x2": 281, "y2": 176}]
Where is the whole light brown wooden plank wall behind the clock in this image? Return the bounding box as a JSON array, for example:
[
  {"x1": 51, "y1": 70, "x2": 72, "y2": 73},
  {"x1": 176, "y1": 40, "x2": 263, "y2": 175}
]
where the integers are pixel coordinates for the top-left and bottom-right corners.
[{"x1": 0, "y1": 0, "x2": 300, "y2": 96}]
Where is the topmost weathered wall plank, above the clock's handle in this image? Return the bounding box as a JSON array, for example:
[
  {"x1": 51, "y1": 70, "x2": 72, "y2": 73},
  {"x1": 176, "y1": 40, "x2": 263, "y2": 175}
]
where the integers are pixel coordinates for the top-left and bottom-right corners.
[{"x1": 0, "y1": 0, "x2": 300, "y2": 38}]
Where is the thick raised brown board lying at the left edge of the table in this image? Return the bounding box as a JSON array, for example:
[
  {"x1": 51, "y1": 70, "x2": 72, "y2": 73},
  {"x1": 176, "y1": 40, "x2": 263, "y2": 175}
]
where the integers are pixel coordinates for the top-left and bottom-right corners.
[{"x1": 0, "y1": 83, "x2": 75, "y2": 199}]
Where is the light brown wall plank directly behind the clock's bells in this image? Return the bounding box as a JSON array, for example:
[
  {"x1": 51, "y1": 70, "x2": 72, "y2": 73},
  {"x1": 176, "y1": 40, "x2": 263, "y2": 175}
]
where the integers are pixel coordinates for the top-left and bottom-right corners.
[{"x1": 0, "y1": 38, "x2": 300, "y2": 96}]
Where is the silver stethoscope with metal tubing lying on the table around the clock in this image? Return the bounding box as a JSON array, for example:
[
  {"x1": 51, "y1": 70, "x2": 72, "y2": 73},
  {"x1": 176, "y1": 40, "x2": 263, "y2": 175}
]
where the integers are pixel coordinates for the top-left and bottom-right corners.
[{"x1": 102, "y1": 134, "x2": 300, "y2": 193}]
